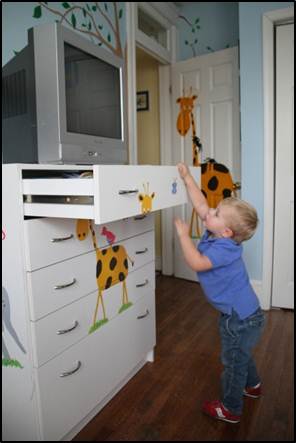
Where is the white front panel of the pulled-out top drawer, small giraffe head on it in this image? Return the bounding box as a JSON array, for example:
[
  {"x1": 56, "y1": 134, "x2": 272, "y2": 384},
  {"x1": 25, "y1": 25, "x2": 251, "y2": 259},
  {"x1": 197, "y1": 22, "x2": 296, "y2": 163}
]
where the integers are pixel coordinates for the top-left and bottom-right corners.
[{"x1": 94, "y1": 165, "x2": 200, "y2": 223}]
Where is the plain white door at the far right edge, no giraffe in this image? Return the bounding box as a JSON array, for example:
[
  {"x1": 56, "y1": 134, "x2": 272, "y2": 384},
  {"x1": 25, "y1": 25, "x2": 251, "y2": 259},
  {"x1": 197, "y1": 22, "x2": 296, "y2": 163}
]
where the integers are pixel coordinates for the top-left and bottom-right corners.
[{"x1": 272, "y1": 25, "x2": 294, "y2": 309}]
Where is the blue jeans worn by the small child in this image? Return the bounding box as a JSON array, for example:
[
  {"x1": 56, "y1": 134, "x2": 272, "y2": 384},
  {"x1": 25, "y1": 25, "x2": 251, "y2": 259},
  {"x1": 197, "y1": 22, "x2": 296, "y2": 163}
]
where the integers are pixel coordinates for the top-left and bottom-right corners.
[{"x1": 219, "y1": 308, "x2": 265, "y2": 415}]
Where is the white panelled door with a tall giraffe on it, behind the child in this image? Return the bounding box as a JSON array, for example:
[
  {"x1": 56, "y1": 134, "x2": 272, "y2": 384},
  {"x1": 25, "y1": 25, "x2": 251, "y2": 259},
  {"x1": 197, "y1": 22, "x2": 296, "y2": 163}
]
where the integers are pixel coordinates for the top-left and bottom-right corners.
[{"x1": 172, "y1": 47, "x2": 240, "y2": 281}]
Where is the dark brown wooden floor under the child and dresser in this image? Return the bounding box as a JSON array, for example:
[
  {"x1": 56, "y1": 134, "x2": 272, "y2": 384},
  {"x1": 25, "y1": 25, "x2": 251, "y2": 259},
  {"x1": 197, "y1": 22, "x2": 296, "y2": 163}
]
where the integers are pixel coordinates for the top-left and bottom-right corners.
[{"x1": 74, "y1": 276, "x2": 294, "y2": 441}]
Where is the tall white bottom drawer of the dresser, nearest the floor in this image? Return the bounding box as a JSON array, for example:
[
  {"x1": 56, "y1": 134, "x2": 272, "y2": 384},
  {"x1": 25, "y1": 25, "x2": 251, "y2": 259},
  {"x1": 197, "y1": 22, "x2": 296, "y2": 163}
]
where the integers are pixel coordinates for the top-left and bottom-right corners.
[{"x1": 36, "y1": 293, "x2": 155, "y2": 441}]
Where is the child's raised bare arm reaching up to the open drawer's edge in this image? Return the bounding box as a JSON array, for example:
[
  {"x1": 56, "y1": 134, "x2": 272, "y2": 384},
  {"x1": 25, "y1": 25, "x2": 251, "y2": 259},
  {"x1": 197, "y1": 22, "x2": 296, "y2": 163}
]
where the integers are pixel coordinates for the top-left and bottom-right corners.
[{"x1": 177, "y1": 163, "x2": 209, "y2": 220}]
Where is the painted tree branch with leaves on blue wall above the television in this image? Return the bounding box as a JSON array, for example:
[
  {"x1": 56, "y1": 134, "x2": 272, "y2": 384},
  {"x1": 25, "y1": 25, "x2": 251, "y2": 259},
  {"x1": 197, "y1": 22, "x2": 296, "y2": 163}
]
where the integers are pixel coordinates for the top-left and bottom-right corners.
[{"x1": 33, "y1": 2, "x2": 123, "y2": 58}]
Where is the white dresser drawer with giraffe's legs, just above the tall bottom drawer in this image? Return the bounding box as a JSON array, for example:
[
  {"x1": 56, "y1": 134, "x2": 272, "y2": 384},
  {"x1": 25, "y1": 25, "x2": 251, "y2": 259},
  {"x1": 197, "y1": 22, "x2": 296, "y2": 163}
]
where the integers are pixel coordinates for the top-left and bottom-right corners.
[{"x1": 31, "y1": 262, "x2": 155, "y2": 367}]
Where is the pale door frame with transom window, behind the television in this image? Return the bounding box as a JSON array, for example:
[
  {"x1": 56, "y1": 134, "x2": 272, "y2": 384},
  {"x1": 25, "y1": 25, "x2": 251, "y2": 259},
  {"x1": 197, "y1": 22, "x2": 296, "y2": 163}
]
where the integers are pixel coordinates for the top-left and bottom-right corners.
[{"x1": 125, "y1": 2, "x2": 178, "y2": 275}]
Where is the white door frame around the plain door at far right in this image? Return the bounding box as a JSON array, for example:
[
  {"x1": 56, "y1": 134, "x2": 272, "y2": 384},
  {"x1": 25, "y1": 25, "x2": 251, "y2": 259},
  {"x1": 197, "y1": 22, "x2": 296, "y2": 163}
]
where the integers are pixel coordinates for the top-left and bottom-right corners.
[{"x1": 261, "y1": 8, "x2": 294, "y2": 309}]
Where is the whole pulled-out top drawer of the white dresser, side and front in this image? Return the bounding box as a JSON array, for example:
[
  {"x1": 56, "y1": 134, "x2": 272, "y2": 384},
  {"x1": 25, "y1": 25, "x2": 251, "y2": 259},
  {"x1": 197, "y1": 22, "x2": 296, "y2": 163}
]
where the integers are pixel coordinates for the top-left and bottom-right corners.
[{"x1": 22, "y1": 165, "x2": 200, "y2": 224}]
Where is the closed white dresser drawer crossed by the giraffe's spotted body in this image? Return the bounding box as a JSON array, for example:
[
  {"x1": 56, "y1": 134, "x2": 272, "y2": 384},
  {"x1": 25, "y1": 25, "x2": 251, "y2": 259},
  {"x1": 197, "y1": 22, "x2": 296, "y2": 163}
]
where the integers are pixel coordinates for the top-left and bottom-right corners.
[{"x1": 27, "y1": 231, "x2": 154, "y2": 321}]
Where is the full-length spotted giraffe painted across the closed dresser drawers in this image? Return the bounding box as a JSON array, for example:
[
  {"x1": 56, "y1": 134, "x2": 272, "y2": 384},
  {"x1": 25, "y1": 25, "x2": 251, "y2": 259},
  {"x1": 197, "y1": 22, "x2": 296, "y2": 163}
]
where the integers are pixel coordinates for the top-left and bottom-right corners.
[{"x1": 76, "y1": 220, "x2": 134, "y2": 333}]
